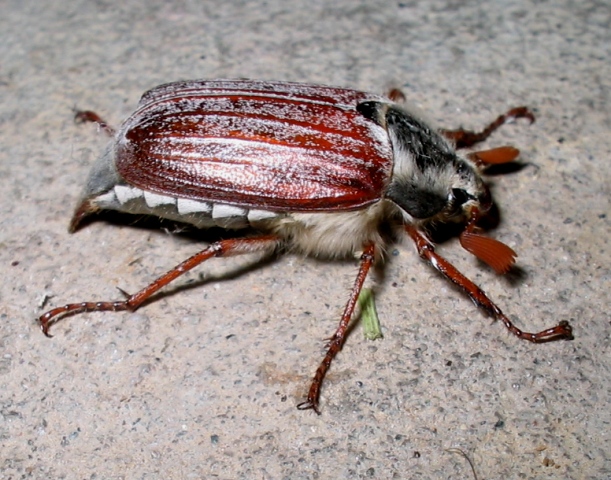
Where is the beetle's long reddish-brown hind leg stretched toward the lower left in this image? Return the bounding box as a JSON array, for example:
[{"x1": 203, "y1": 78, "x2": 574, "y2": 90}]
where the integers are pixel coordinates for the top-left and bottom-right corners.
[{"x1": 38, "y1": 235, "x2": 280, "y2": 337}]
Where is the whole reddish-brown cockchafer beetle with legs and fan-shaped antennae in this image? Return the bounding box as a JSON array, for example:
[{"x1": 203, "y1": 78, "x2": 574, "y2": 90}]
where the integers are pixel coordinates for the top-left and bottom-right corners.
[{"x1": 38, "y1": 80, "x2": 572, "y2": 413}]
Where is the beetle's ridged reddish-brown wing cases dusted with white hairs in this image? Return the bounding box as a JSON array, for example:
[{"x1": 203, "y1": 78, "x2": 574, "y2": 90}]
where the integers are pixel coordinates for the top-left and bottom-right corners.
[{"x1": 116, "y1": 80, "x2": 393, "y2": 211}]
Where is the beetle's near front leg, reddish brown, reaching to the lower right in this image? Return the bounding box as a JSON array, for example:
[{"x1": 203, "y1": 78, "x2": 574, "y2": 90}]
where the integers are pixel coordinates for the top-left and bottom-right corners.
[{"x1": 405, "y1": 225, "x2": 573, "y2": 343}]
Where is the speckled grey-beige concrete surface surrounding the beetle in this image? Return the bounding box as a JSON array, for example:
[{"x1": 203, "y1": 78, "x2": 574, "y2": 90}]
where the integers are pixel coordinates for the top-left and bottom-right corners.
[{"x1": 0, "y1": 0, "x2": 611, "y2": 479}]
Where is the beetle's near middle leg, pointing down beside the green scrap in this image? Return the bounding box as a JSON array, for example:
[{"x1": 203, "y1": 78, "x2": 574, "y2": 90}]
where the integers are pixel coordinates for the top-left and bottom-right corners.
[{"x1": 297, "y1": 243, "x2": 375, "y2": 414}]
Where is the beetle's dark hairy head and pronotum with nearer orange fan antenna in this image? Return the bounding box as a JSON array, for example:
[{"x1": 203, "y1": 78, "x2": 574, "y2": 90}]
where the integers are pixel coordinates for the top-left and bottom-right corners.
[{"x1": 357, "y1": 102, "x2": 516, "y2": 273}]
